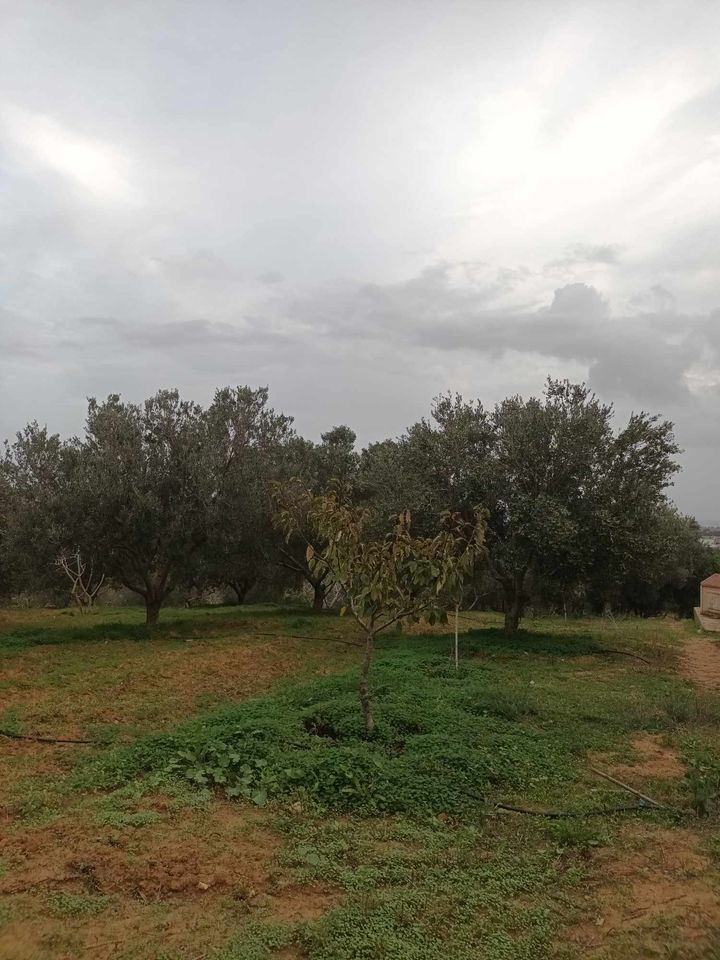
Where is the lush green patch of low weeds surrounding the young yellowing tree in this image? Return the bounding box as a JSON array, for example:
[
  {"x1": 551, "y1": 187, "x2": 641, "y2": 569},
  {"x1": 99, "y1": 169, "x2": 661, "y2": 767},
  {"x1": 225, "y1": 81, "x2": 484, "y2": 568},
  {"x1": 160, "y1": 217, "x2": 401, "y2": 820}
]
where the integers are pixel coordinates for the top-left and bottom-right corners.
[{"x1": 78, "y1": 631, "x2": 708, "y2": 815}]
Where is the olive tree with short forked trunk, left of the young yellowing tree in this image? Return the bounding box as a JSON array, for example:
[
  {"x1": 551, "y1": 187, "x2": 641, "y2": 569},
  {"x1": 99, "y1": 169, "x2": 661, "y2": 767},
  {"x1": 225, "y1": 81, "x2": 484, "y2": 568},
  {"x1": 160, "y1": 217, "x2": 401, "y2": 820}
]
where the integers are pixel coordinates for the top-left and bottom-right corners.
[{"x1": 69, "y1": 390, "x2": 213, "y2": 626}]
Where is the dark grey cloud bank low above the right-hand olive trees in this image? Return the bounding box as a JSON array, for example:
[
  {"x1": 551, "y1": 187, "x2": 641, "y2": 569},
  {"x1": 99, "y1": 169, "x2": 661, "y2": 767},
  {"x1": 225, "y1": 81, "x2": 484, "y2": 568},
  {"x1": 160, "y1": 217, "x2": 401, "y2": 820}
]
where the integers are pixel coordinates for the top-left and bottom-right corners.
[{"x1": 274, "y1": 265, "x2": 720, "y2": 406}]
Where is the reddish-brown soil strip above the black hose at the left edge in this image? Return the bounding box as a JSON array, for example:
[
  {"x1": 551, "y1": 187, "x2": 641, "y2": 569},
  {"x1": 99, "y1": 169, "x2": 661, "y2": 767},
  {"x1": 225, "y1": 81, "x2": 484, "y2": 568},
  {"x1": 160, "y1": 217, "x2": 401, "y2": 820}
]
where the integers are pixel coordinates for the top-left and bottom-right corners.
[{"x1": 0, "y1": 633, "x2": 354, "y2": 737}]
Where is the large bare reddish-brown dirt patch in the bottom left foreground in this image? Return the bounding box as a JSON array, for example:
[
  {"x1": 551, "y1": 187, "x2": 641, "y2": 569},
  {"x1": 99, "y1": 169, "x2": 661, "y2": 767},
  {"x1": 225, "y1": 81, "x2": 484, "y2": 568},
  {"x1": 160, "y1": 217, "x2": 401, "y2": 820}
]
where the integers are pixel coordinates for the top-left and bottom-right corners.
[{"x1": 0, "y1": 797, "x2": 337, "y2": 960}]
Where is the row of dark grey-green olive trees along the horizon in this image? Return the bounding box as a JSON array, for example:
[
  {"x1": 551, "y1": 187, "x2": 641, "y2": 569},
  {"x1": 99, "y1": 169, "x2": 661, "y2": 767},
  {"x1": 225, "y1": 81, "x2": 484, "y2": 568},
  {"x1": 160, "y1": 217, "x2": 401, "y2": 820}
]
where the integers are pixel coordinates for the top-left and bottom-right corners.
[{"x1": 0, "y1": 380, "x2": 714, "y2": 631}]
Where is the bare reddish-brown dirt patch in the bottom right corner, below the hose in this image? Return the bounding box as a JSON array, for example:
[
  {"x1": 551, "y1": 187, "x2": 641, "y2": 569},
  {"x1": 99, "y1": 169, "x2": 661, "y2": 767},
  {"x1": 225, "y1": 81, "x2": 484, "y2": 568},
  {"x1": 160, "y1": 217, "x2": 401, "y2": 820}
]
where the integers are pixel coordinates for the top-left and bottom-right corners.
[{"x1": 569, "y1": 825, "x2": 720, "y2": 956}]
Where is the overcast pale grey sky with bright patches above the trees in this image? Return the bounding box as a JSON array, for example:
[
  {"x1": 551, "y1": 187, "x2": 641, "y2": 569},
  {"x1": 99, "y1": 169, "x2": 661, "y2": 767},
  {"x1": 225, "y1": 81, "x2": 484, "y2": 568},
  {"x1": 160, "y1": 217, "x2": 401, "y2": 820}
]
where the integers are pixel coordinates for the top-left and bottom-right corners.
[{"x1": 0, "y1": 0, "x2": 720, "y2": 523}]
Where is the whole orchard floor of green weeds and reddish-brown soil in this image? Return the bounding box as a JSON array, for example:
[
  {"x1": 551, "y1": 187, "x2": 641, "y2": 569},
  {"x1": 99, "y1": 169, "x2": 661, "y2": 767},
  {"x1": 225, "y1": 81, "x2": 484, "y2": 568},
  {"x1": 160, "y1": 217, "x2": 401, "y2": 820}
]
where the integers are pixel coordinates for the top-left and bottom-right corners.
[{"x1": 0, "y1": 607, "x2": 720, "y2": 960}]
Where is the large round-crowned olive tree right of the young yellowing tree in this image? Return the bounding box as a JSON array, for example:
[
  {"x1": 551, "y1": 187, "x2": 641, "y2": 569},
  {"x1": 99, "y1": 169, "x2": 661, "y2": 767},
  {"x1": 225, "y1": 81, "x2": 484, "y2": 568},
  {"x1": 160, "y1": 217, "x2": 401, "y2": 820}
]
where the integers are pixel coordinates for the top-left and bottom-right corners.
[{"x1": 360, "y1": 380, "x2": 678, "y2": 632}]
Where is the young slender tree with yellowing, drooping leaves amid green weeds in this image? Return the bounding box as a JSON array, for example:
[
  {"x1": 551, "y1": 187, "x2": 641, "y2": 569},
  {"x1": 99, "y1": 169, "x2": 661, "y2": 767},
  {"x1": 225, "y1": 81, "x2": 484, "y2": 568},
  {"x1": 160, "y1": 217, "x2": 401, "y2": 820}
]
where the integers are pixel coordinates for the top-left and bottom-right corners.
[{"x1": 276, "y1": 484, "x2": 484, "y2": 735}]
